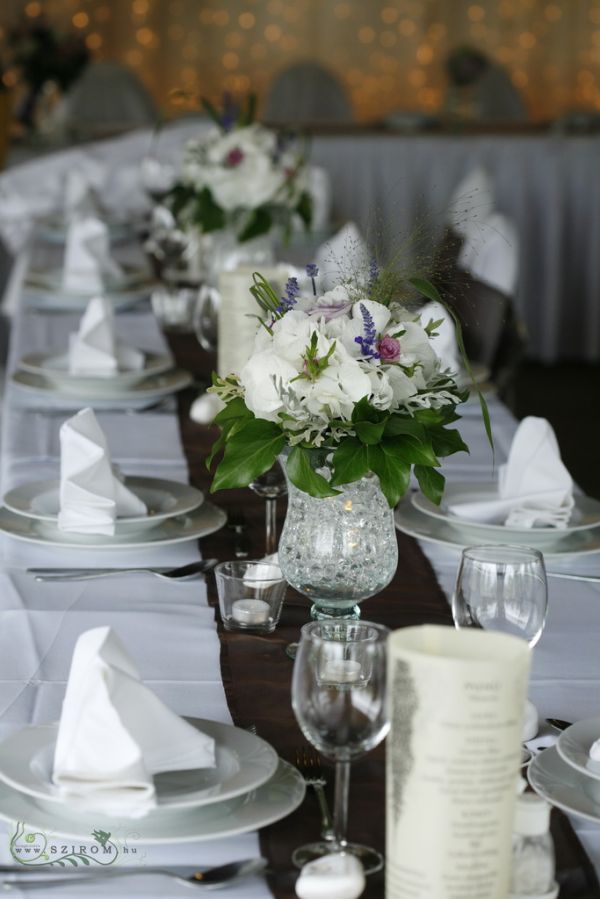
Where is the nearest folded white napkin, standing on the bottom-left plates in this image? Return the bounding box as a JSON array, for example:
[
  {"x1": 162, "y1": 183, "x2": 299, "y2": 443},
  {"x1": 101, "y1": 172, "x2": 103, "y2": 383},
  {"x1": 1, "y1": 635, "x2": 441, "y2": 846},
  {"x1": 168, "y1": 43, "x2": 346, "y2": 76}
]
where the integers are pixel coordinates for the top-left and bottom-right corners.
[{"x1": 52, "y1": 627, "x2": 215, "y2": 818}]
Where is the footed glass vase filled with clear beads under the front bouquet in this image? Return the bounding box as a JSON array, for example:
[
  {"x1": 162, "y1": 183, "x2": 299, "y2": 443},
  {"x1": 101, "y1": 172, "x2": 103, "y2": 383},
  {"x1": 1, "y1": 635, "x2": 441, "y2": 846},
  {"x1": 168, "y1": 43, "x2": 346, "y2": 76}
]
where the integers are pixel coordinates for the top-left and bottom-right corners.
[{"x1": 279, "y1": 450, "x2": 398, "y2": 619}]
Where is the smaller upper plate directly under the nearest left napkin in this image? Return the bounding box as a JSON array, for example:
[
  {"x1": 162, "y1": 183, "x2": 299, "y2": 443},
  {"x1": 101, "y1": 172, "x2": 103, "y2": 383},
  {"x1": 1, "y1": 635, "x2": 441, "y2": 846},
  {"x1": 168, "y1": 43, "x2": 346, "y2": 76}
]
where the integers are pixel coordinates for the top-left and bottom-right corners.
[{"x1": 0, "y1": 718, "x2": 279, "y2": 815}]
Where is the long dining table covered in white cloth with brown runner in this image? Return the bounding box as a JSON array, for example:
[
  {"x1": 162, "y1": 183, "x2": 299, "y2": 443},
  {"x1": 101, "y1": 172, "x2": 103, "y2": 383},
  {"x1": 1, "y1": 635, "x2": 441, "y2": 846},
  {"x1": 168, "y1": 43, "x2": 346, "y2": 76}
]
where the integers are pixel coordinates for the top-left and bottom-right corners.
[{"x1": 0, "y1": 243, "x2": 600, "y2": 899}]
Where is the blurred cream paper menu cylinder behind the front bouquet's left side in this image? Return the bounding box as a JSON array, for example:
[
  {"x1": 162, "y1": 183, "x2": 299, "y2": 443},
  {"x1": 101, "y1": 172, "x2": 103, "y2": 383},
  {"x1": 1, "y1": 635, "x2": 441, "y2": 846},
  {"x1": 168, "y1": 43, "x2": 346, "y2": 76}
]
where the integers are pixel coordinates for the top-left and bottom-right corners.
[{"x1": 217, "y1": 264, "x2": 287, "y2": 377}]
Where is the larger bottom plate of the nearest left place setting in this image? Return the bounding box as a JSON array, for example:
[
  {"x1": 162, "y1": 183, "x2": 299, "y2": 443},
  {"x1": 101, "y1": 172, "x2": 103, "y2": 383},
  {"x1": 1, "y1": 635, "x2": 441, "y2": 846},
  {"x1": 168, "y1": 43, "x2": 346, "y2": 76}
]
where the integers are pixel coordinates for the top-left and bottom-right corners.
[{"x1": 0, "y1": 759, "x2": 306, "y2": 845}]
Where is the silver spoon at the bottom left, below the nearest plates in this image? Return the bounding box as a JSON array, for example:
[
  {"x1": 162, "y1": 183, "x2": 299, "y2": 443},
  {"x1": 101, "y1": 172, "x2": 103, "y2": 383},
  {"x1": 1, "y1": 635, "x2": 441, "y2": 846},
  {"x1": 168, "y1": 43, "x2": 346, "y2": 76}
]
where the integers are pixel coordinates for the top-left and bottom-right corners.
[{"x1": 0, "y1": 858, "x2": 267, "y2": 892}]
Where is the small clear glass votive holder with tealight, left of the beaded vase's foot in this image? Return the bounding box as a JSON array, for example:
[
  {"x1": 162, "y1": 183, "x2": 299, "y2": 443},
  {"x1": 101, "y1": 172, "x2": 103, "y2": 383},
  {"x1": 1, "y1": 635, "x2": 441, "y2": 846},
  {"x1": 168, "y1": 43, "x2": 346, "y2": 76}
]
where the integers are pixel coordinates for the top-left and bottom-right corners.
[{"x1": 215, "y1": 559, "x2": 287, "y2": 634}]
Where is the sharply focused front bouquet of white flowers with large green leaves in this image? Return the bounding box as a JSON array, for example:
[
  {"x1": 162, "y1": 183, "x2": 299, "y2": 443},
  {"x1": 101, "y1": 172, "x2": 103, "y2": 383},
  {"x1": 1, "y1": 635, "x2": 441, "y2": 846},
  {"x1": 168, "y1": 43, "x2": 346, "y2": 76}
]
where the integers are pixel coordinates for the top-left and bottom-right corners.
[{"x1": 209, "y1": 263, "x2": 491, "y2": 507}]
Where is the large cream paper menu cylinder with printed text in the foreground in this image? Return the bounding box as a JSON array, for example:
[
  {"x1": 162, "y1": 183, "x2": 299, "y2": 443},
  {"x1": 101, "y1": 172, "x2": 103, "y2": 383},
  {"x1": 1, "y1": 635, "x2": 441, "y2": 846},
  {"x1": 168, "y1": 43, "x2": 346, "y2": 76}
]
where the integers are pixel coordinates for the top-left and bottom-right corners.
[{"x1": 386, "y1": 625, "x2": 530, "y2": 899}]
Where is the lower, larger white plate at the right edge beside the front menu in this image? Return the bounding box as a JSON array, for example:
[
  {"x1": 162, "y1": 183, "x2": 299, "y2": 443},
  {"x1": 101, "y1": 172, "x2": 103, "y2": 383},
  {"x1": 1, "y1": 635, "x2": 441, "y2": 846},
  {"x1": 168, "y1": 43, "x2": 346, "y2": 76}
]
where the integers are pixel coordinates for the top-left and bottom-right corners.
[{"x1": 527, "y1": 746, "x2": 600, "y2": 824}]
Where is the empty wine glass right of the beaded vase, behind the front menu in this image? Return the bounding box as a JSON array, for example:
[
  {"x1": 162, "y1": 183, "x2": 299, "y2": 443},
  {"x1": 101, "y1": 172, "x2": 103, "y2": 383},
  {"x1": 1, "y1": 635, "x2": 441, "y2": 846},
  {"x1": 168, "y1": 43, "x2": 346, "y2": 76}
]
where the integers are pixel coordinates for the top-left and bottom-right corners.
[{"x1": 452, "y1": 545, "x2": 548, "y2": 647}]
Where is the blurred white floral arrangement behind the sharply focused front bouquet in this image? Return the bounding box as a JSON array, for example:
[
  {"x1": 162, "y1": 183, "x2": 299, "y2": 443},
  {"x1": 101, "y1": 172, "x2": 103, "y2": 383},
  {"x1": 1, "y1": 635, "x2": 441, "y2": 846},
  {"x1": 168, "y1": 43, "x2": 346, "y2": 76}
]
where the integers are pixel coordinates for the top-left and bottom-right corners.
[{"x1": 167, "y1": 97, "x2": 311, "y2": 243}]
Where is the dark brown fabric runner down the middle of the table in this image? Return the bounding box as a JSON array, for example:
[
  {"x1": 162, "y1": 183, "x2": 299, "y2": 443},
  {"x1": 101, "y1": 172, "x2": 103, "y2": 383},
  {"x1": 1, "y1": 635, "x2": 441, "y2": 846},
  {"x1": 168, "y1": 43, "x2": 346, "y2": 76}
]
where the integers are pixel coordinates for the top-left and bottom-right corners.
[{"x1": 171, "y1": 336, "x2": 600, "y2": 899}]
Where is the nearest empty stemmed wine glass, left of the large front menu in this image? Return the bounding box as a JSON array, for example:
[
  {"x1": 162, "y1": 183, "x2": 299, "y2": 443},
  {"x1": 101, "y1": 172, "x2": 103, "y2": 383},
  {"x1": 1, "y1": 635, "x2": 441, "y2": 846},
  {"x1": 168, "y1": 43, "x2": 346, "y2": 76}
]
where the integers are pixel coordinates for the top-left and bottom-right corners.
[{"x1": 292, "y1": 619, "x2": 389, "y2": 874}]
